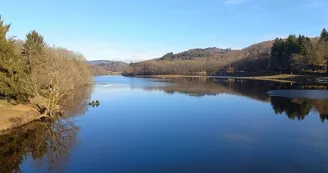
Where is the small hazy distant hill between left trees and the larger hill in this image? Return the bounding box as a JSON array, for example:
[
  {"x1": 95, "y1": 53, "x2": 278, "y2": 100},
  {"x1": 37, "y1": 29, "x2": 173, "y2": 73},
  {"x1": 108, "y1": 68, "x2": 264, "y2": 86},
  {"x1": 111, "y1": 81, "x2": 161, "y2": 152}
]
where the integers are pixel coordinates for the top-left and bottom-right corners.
[{"x1": 88, "y1": 60, "x2": 129, "y2": 76}]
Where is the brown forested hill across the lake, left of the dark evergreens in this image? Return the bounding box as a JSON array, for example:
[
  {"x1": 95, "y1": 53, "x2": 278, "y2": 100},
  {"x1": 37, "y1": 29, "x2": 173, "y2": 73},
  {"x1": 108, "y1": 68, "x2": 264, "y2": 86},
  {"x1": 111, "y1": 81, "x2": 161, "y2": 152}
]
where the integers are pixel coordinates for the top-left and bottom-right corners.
[{"x1": 124, "y1": 41, "x2": 274, "y2": 75}]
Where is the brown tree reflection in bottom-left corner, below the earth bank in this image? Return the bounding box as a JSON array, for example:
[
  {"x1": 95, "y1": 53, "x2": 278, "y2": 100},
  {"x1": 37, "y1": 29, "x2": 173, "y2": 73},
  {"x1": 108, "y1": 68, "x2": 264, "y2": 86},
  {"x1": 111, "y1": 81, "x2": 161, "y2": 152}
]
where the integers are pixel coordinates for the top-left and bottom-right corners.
[{"x1": 0, "y1": 120, "x2": 79, "y2": 173}]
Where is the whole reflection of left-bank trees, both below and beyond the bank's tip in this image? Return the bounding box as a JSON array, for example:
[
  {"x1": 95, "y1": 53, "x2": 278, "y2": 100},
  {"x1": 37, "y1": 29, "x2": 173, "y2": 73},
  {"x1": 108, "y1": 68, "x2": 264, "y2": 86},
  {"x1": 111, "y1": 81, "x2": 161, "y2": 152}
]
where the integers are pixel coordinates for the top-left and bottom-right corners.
[{"x1": 0, "y1": 86, "x2": 92, "y2": 173}]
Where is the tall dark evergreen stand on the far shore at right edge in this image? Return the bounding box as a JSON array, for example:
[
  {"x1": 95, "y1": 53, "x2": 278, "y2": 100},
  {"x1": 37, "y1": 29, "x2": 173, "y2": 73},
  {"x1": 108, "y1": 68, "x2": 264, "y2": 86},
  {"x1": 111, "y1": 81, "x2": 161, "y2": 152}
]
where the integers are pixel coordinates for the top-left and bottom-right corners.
[{"x1": 269, "y1": 29, "x2": 328, "y2": 73}]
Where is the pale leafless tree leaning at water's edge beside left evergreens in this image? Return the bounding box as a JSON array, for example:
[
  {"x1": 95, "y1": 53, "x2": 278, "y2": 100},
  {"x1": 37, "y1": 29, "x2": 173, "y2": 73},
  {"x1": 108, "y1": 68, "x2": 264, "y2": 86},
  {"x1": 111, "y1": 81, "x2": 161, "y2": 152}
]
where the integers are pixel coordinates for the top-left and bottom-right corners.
[{"x1": 24, "y1": 48, "x2": 91, "y2": 117}]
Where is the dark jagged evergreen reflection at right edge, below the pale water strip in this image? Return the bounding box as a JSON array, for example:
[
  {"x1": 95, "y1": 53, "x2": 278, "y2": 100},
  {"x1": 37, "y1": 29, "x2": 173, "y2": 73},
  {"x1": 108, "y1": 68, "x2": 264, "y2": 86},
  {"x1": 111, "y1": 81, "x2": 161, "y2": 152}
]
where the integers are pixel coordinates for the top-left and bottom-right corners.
[{"x1": 271, "y1": 97, "x2": 328, "y2": 121}]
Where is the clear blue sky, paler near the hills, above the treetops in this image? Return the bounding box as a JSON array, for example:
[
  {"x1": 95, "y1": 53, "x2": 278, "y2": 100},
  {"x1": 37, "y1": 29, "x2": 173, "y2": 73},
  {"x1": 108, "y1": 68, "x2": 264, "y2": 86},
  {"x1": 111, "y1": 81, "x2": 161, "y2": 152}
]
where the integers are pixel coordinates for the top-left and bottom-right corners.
[{"x1": 0, "y1": 0, "x2": 328, "y2": 61}]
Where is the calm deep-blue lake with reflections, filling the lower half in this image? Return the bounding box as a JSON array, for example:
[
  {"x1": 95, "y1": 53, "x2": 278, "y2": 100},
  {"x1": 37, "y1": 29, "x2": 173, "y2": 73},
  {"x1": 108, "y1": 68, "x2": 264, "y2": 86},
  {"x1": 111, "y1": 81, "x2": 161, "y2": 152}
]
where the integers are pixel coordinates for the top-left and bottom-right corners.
[{"x1": 0, "y1": 76, "x2": 328, "y2": 173}]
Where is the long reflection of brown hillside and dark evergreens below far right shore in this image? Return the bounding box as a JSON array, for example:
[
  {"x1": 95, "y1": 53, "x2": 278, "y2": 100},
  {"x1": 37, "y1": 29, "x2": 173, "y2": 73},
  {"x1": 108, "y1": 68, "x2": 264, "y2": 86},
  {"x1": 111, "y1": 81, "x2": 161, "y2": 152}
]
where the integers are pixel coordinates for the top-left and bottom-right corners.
[{"x1": 144, "y1": 78, "x2": 328, "y2": 121}]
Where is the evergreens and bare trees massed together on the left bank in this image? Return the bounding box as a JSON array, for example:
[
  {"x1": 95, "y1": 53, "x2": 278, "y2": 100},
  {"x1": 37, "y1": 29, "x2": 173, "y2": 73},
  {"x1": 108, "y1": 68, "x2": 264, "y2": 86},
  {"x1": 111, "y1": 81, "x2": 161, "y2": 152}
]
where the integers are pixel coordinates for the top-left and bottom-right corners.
[{"x1": 0, "y1": 16, "x2": 91, "y2": 116}]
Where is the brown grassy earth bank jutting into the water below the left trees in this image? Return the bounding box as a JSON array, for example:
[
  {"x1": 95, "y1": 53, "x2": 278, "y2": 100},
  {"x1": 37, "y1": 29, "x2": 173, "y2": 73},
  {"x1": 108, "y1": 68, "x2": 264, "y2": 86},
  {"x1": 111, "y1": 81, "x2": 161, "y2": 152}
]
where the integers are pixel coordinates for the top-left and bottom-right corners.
[{"x1": 0, "y1": 100, "x2": 41, "y2": 131}]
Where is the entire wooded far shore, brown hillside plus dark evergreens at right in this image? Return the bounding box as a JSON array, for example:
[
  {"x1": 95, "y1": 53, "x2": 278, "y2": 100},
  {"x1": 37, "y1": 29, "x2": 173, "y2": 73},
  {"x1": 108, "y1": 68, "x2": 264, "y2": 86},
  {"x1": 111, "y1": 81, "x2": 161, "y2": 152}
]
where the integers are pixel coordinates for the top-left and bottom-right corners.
[{"x1": 123, "y1": 29, "x2": 328, "y2": 76}]
